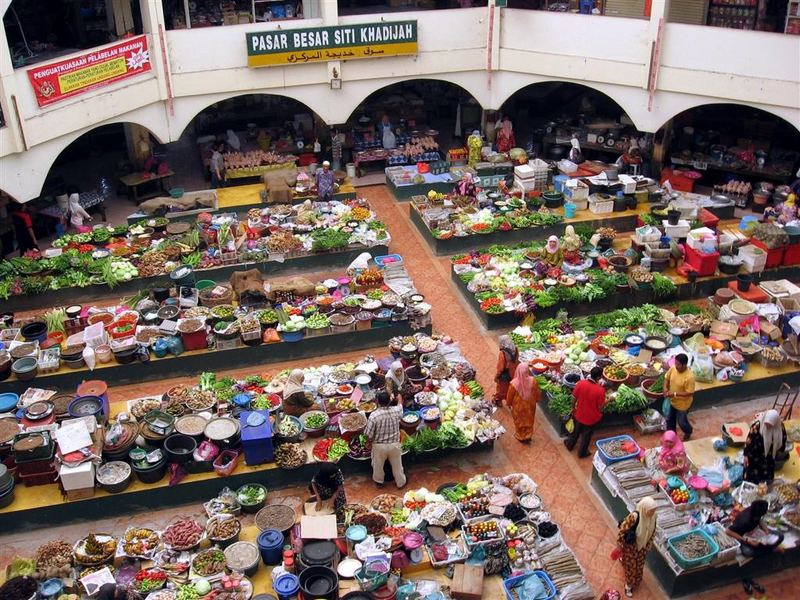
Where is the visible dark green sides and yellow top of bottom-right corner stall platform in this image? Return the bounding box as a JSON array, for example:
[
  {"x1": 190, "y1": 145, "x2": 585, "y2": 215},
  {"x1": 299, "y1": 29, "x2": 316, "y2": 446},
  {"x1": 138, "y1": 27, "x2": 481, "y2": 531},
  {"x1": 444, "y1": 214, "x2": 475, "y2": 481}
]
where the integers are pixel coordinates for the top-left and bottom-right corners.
[{"x1": 591, "y1": 438, "x2": 800, "y2": 597}]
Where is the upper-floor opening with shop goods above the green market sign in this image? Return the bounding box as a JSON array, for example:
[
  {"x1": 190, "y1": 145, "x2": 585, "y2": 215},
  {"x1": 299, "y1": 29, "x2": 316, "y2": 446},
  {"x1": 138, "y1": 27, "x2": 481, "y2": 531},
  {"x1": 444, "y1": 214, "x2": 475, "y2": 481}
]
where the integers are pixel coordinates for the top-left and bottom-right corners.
[{"x1": 163, "y1": 0, "x2": 325, "y2": 29}]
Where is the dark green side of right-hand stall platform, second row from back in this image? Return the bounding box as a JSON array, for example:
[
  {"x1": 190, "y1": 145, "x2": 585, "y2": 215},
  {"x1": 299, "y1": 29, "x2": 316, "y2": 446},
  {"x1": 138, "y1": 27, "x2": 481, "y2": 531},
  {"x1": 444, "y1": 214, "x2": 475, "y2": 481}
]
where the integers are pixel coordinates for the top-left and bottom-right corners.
[{"x1": 416, "y1": 202, "x2": 640, "y2": 256}]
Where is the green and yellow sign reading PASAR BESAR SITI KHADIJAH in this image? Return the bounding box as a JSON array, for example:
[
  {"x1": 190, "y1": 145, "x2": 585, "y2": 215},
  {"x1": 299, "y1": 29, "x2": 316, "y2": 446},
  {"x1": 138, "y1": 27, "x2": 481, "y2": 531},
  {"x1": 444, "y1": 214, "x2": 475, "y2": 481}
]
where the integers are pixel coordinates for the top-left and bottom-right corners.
[{"x1": 245, "y1": 21, "x2": 418, "y2": 67}]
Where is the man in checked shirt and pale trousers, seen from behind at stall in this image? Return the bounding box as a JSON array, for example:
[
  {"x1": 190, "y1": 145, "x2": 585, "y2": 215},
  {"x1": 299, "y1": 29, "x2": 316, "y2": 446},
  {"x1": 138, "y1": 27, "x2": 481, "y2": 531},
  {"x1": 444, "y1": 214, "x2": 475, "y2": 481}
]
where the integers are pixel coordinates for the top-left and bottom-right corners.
[{"x1": 365, "y1": 391, "x2": 406, "y2": 489}]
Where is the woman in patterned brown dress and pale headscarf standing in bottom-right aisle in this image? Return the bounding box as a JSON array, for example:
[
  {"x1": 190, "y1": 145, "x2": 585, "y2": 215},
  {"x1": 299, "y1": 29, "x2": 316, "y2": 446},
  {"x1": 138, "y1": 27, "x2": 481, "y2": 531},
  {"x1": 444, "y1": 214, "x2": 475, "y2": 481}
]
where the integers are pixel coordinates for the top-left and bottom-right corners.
[{"x1": 617, "y1": 496, "x2": 656, "y2": 598}]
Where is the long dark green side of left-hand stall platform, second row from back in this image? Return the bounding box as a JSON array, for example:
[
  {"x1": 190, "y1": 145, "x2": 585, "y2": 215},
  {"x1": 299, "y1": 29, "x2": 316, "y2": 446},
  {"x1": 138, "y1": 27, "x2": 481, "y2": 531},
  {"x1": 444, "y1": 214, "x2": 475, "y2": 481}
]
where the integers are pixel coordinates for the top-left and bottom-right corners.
[{"x1": 0, "y1": 321, "x2": 431, "y2": 394}]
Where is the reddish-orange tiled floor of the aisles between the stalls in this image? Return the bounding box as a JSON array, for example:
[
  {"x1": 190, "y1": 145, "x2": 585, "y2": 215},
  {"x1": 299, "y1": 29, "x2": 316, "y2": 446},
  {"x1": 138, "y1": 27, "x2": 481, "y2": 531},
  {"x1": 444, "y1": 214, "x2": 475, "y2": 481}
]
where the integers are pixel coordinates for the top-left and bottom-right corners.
[{"x1": 0, "y1": 186, "x2": 798, "y2": 600}]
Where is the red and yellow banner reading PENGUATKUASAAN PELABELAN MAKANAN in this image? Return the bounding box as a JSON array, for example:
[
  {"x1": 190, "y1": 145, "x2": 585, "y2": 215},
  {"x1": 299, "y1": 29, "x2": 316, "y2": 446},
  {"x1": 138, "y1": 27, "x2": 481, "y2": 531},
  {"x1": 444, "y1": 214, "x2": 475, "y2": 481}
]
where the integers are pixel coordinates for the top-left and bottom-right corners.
[{"x1": 28, "y1": 35, "x2": 151, "y2": 106}]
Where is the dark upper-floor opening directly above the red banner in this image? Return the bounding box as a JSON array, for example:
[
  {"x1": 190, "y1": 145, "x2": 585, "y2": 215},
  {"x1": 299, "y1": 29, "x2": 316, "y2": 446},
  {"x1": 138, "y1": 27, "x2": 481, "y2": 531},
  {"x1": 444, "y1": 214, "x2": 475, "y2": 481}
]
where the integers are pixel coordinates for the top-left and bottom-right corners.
[{"x1": 3, "y1": 0, "x2": 142, "y2": 68}]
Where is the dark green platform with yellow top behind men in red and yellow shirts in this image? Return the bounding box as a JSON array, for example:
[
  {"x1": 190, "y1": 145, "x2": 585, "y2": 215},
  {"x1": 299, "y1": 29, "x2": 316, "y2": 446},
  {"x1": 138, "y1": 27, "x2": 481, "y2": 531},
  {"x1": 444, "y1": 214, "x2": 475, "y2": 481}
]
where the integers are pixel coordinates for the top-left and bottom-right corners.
[{"x1": 539, "y1": 362, "x2": 800, "y2": 434}]
